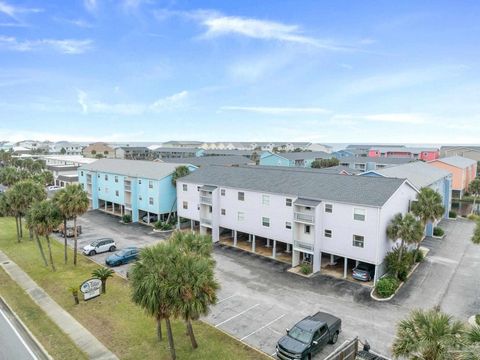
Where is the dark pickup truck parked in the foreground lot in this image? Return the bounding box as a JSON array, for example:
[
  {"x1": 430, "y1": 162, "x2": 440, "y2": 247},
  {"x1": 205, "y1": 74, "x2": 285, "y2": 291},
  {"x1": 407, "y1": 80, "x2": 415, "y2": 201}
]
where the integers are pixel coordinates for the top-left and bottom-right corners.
[{"x1": 276, "y1": 312, "x2": 342, "y2": 360}]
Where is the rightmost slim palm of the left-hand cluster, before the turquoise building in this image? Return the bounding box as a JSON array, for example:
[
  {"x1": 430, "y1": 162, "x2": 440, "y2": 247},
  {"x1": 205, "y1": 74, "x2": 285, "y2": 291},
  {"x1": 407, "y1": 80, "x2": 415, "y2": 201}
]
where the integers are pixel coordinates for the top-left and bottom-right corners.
[{"x1": 62, "y1": 184, "x2": 88, "y2": 266}]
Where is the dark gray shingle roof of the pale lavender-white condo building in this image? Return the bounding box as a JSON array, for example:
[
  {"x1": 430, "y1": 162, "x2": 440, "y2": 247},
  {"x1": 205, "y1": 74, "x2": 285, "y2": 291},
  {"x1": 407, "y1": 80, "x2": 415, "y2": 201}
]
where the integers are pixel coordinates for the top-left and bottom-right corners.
[{"x1": 181, "y1": 165, "x2": 405, "y2": 206}]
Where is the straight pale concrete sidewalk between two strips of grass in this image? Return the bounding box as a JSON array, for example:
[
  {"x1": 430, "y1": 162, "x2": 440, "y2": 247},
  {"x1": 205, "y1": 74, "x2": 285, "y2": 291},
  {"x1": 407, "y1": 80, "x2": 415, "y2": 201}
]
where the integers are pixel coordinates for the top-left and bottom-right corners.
[{"x1": 0, "y1": 251, "x2": 118, "y2": 360}]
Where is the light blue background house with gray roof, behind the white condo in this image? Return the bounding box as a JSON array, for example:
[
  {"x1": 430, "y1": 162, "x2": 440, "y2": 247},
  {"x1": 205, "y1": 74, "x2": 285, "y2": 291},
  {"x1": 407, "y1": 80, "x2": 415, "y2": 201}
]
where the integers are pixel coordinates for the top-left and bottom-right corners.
[{"x1": 260, "y1": 151, "x2": 332, "y2": 168}]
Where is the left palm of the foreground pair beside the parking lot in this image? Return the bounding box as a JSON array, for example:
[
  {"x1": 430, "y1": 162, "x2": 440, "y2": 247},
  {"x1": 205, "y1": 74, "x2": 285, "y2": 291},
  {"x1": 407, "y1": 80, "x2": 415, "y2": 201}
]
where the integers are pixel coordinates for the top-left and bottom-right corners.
[{"x1": 129, "y1": 243, "x2": 178, "y2": 360}]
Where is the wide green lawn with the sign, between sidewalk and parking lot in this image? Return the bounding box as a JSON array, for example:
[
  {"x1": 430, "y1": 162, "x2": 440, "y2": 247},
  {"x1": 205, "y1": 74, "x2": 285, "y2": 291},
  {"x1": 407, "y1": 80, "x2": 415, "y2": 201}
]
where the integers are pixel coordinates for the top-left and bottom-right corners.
[{"x1": 0, "y1": 218, "x2": 267, "y2": 360}]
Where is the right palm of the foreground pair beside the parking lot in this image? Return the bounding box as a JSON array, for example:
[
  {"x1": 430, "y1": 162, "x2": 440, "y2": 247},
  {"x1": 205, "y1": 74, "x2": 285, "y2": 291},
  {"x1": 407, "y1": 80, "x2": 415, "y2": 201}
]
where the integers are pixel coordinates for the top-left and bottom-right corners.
[{"x1": 170, "y1": 253, "x2": 220, "y2": 349}]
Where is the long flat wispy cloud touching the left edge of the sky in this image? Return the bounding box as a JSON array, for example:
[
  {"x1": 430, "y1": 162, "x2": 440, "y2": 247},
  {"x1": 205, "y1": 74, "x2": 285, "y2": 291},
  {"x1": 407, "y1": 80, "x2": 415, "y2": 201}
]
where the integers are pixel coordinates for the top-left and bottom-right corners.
[{"x1": 0, "y1": 36, "x2": 93, "y2": 55}]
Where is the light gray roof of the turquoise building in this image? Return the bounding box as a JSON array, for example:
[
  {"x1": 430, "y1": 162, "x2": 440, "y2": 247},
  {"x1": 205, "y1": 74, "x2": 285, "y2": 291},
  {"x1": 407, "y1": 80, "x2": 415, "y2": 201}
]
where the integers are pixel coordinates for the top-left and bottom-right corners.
[{"x1": 78, "y1": 159, "x2": 187, "y2": 180}]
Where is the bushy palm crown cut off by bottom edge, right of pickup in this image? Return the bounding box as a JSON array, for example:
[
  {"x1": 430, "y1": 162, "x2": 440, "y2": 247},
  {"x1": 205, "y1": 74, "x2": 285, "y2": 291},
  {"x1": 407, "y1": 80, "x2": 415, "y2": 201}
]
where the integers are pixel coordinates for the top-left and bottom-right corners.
[{"x1": 392, "y1": 308, "x2": 464, "y2": 360}]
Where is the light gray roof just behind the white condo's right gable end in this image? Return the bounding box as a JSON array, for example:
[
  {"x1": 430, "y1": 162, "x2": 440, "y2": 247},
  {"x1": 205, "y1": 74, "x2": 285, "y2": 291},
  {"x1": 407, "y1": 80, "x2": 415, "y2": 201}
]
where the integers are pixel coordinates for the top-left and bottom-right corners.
[{"x1": 366, "y1": 161, "x2": 450, "y2": 188}]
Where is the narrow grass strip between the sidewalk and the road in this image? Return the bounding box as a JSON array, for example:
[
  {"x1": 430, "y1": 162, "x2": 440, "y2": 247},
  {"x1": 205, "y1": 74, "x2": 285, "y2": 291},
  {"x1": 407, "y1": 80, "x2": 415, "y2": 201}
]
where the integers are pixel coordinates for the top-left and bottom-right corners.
[{"x1": 0, "y1": 268, "x2": 87, "y2": 360}]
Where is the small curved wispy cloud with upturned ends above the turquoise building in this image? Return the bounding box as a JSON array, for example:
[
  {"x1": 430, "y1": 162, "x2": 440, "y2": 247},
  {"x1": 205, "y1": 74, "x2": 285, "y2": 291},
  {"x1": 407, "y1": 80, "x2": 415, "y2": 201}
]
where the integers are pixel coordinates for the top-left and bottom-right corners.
[{"x1": 77, "y1": 90, "x2": 188, "y2": 116}]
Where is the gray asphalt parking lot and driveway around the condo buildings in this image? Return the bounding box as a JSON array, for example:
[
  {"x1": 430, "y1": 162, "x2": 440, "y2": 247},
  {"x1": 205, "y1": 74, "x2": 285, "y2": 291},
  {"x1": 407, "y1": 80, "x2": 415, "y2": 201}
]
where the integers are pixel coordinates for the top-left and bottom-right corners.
[{"x1": 66, "y1": 211, "x2": 480, "y2": 359}]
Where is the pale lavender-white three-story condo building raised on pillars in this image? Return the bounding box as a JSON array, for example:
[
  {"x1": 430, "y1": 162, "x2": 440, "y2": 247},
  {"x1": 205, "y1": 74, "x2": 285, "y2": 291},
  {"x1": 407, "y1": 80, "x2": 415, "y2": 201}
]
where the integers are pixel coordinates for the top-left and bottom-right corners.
[{"x1": 177, "y1": 165, "x2": 417, "y2": 280}]
